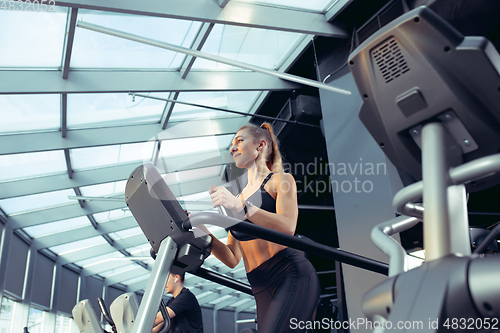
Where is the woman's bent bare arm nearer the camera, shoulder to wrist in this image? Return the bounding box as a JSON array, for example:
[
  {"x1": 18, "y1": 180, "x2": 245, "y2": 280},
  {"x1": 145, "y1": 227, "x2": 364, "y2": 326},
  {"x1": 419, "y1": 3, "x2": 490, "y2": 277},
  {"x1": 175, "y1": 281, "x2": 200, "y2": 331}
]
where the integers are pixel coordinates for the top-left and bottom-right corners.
[{"x1": 246, "y1": 173, "x2": 299, "y2": 235}]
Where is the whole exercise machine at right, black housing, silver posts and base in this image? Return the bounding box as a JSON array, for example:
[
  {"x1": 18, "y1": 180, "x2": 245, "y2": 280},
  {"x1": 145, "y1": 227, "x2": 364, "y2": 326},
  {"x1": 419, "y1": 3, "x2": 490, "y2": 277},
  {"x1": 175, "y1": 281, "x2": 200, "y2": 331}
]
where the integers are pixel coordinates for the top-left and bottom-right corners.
[{"x1": 349, "y1": 7, "x2": 500, "y2": 332}]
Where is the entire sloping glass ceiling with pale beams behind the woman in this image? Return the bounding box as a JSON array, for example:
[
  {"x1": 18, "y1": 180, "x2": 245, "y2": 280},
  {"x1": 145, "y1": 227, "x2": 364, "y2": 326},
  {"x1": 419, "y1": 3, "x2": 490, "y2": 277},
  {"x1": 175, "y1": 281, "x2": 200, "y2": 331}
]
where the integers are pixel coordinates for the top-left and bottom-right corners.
[{"x1": 0, "y1": 0, "x2": 328, "y2": 316}]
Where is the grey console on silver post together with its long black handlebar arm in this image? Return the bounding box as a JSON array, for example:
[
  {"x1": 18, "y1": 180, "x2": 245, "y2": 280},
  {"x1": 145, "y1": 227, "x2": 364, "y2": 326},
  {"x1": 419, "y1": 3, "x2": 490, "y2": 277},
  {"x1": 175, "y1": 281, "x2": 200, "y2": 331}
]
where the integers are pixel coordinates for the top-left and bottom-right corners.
[{"x1": 125, "y1": 164, "x2": 388, "y2": 333}]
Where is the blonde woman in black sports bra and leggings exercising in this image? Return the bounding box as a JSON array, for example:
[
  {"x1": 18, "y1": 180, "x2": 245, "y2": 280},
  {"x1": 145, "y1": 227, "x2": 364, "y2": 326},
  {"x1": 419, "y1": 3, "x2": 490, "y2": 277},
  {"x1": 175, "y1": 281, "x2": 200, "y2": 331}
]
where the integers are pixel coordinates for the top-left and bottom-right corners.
[{"x1": 210, "y1": 123, "x2": 320, "y2": 333}]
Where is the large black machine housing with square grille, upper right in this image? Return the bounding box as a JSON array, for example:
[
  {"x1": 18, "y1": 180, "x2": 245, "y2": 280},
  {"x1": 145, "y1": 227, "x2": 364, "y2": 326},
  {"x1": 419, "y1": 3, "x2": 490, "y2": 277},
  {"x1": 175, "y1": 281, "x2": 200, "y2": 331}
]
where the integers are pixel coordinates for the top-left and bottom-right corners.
[{"x1": 349, "y1": 7, "x2": 500, "y2": 192}]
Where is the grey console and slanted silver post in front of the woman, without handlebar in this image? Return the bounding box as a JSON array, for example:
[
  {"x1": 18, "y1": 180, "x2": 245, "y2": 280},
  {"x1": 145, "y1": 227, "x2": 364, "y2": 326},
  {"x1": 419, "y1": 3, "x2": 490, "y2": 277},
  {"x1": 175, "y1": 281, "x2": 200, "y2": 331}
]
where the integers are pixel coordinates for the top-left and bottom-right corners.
[{"x1": 125, "y1": 164, "x2": 211, "y2": 333}]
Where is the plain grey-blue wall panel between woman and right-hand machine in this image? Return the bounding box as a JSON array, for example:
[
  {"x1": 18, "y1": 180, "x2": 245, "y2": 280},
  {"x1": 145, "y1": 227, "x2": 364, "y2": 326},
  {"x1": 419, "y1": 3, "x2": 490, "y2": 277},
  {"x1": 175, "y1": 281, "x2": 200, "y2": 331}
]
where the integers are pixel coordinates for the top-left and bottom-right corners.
[{"x1": 320, "y1": 59, "x2": 402, "y2": 332}]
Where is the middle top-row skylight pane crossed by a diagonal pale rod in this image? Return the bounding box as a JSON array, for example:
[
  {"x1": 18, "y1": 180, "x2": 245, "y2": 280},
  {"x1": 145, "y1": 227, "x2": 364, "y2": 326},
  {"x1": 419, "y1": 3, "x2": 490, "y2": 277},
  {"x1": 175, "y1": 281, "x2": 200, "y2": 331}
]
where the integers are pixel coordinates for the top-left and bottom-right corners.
[{"x1": 71, "y1": 10, "x2": 201, "y2": 69}]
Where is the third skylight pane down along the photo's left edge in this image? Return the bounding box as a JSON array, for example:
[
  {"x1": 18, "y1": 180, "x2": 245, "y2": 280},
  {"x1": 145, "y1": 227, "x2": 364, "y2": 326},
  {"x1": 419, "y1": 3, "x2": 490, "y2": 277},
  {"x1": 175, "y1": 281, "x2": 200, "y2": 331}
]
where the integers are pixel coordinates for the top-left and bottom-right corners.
[{"x1": 0, "y1": 150, "x2": 67, "y2": 182}]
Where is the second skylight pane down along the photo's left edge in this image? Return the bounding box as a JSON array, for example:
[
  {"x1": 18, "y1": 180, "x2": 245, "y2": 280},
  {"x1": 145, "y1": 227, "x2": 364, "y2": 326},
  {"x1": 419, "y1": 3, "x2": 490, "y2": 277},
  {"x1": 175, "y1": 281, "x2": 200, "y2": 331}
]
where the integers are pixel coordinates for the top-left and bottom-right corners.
[{"x1": 0, "y1": 93, "x2": 61, "y2": 134}]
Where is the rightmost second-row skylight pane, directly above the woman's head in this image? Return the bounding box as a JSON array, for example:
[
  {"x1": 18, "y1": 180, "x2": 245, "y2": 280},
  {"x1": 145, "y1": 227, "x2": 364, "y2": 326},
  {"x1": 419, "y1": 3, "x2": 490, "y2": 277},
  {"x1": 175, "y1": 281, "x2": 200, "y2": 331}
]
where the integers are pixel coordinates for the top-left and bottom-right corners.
[{"x1": 170, "y1": 91, "x2": 260, "y2": 121}]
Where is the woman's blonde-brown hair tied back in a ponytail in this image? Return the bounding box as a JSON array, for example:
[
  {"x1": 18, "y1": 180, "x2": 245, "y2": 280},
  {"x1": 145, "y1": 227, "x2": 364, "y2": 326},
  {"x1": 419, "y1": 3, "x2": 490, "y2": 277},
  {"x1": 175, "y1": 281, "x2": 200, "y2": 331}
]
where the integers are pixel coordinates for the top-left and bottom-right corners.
[{"x1": 238, "y1": 122, "x2": 283, "y2": 173}]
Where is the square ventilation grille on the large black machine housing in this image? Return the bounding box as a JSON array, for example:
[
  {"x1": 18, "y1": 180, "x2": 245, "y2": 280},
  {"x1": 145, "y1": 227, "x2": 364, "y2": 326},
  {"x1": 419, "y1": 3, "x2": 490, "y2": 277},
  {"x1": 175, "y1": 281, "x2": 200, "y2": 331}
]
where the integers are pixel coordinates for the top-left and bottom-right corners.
[{"x1": 372, "y1": 38, "x2": 410, "y2": 83}]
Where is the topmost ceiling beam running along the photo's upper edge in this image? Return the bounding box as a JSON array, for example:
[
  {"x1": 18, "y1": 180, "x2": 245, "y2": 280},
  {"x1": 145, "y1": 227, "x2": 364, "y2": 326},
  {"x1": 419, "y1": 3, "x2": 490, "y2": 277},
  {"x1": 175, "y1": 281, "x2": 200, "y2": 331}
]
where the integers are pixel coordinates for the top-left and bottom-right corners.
[{"x1": 52, "y1": 0, "x2": 346, "y2": 37}]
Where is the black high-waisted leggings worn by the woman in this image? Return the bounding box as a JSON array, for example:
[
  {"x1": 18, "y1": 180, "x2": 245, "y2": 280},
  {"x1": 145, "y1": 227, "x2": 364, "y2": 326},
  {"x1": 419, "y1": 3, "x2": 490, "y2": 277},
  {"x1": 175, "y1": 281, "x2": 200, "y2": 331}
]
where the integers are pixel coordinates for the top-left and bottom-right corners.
[{"x1": 247, "y1": 248, "x2": 320, "y2": 333}]
